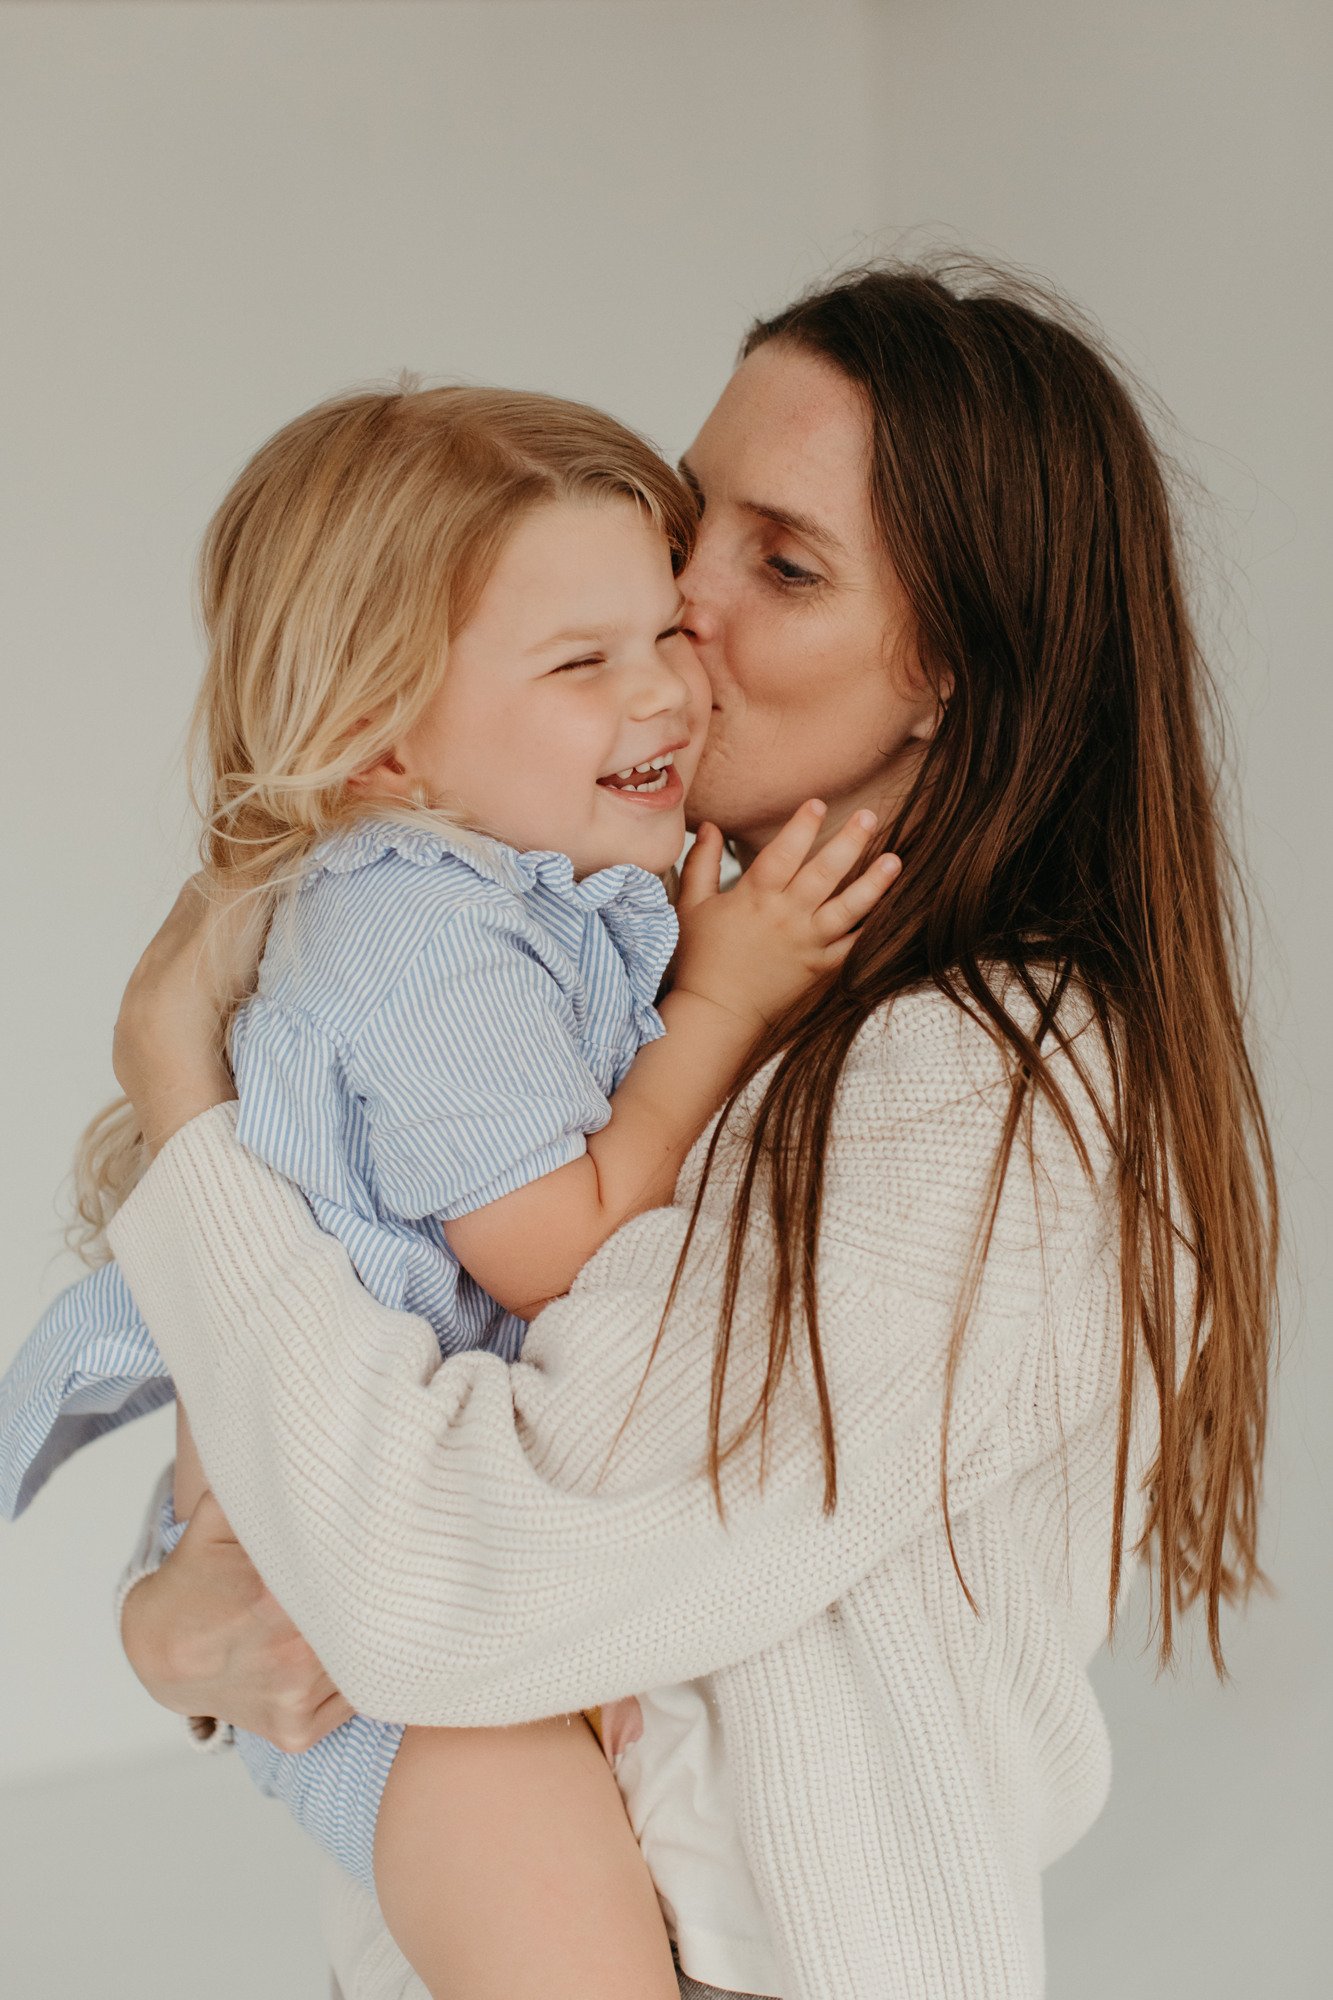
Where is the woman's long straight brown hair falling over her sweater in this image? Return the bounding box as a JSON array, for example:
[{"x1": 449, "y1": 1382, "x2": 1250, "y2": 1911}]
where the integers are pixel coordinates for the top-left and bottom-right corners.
[{"x1": 691, "y1": 264, "x2": 1277, "y2": 1672}]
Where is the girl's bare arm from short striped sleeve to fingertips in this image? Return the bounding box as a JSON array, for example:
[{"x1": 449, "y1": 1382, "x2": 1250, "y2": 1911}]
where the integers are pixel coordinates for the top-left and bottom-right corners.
[{"x1": 444, "y1": 800, "x2": 899, "y2": 1320}]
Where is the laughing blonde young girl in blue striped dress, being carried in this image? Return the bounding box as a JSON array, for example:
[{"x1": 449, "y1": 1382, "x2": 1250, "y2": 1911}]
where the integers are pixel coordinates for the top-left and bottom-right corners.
[{"x1": 0, "y1": 390, "x2": 897, "y2": 2000}]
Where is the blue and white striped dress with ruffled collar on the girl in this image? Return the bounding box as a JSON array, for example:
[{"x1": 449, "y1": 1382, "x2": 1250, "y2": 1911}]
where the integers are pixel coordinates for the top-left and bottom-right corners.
[{"x1": 0, "y1": 820, "x2": 677, "y2": 1890}]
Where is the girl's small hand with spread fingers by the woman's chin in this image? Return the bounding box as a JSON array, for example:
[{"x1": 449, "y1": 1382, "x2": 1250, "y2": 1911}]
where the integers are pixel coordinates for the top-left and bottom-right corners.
[{"x1": 675, "y1": 798, "x2": 903, "y2": 1032}]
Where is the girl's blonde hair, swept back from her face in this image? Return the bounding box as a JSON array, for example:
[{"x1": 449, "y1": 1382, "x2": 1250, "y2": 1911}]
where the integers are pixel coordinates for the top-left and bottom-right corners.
[{"x1": 70, "y1": 384, "x2": 697, "y2": 1262}]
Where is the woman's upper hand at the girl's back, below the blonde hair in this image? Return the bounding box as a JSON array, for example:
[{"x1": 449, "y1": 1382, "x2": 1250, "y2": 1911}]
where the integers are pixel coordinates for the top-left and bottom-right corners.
[{"x1": 112, "y1": 876, "x2": 266, "y2": 1158}]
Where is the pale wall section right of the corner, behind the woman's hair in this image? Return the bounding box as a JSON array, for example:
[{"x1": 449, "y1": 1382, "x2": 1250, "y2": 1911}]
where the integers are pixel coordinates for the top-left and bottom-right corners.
[{"x1": 860, "y1": 0, "x2": 1333, "y2": 2000}]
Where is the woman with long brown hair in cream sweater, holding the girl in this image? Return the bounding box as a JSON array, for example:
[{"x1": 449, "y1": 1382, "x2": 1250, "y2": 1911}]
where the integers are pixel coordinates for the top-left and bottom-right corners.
[{"x1": 101, "y1": 268, "x2": 1275, "y2": 2000}]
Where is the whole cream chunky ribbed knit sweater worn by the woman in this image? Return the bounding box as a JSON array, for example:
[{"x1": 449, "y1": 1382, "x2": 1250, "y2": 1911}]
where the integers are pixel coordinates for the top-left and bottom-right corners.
[{"x1": 112, "y1": 994, "x2": 1151, "y2": 2000}]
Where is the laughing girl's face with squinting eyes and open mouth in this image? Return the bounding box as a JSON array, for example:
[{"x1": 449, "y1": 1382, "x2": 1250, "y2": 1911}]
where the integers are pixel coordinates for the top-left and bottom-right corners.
[{"x1": 360, "y1": 500, "x2": 709, "y2": 876}]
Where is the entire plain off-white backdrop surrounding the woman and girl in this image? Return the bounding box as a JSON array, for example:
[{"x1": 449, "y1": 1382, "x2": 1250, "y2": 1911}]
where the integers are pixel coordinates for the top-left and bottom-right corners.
[{"x1": 0, "y1": 0, "x2": 1333, "y2": 2000}]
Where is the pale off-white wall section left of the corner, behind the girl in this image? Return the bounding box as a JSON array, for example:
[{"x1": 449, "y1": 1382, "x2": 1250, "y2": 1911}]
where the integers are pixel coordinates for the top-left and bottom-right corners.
[{"x1": 0, "y1": 0, "x2": 871, "y2": 1778}]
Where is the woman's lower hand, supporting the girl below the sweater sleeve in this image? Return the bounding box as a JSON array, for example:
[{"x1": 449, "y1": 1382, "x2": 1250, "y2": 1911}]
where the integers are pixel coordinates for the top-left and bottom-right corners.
[{"x1": 120, "y1": 1492, "x2": 352, "y2": 1752}]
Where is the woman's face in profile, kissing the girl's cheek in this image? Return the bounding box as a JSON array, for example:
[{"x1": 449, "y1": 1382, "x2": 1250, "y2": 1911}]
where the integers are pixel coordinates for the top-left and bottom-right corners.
[{"x1": 681, "y1": 342, "x2": 937, "y2": 860}]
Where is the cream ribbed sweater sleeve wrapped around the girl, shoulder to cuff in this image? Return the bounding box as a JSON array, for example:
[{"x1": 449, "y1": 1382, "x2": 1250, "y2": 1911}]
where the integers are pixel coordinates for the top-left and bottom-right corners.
[{"x1": 114, "y1": 1002, "x2": 1105, "y2": 1726}]
